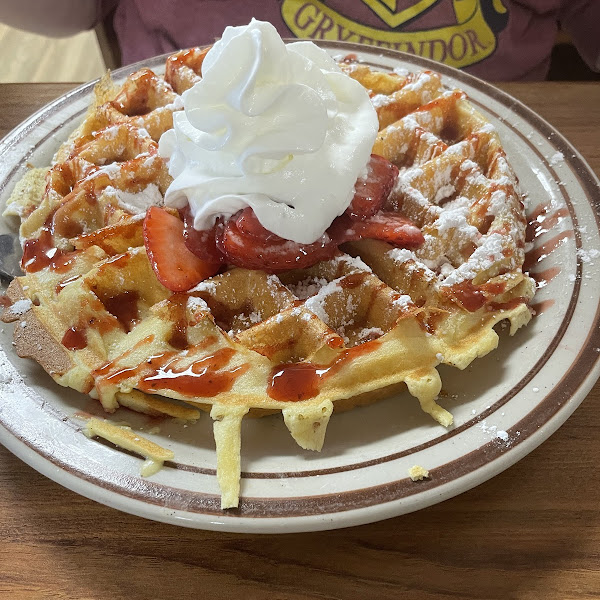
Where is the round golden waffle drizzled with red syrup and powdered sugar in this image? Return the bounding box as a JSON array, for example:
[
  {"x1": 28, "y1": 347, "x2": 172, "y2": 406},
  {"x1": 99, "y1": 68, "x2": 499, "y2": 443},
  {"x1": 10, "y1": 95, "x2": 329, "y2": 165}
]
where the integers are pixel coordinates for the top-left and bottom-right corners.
[{"x1": 3, "y1": 49, "x2": 534, "y2": 508}]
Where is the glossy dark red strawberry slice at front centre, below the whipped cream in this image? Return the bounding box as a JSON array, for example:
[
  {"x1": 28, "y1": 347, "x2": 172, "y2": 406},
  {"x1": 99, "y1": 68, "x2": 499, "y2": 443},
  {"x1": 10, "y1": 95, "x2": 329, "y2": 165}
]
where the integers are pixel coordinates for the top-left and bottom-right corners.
[{"x1": 217, "y1": 208, "x2": 338, "y2": 273}]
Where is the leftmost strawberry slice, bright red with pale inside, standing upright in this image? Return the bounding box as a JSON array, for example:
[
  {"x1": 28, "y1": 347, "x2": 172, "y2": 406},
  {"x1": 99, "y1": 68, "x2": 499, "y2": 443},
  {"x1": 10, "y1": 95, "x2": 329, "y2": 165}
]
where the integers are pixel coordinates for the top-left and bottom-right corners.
[{"x1": 144, "y1": 206, "x2": 220, "y2": 292}]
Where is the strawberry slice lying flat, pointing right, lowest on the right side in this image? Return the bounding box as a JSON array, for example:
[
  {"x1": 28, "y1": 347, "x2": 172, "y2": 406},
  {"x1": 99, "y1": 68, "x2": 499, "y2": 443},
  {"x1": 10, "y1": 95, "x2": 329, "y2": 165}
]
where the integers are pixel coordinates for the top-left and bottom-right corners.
[{"x1": 327, "y1": 211, "x2": 425, "y2": 248}]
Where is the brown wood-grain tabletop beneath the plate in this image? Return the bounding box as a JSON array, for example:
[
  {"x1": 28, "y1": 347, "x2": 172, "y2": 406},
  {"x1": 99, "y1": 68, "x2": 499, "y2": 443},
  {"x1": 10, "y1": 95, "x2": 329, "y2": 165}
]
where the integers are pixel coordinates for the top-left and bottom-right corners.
[{"x1": 0, "y1": 83, "x2": 600, "y2": 600}]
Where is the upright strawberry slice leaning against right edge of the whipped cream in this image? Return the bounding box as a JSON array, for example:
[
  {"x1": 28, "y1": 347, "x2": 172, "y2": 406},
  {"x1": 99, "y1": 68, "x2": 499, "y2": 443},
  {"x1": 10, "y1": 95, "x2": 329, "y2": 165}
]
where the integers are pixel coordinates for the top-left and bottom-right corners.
[{"x1": 346, "y1": 154, "x2": 398, "y2": 220}]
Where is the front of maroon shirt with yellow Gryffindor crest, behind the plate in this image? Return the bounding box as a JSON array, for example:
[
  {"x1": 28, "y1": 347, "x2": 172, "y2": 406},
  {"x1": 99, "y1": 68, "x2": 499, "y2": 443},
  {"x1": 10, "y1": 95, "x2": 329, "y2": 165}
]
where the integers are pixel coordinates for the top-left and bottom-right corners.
[{"x1": 115, "y1": 0, "x2": 559, "y2": 80}]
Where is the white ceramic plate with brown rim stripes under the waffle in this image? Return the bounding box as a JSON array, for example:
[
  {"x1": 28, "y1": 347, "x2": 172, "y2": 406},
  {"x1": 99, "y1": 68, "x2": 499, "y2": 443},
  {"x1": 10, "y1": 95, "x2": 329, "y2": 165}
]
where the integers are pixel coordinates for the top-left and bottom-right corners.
[{"x1": 0, "y1": 43, "x2": 600, "y2": 532}]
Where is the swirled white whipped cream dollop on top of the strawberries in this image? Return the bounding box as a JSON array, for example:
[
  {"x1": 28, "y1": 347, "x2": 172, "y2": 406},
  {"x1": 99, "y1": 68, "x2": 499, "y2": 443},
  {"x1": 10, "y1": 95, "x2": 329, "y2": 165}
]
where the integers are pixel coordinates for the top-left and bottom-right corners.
[{"x1": 159, "y1": 20, "x2": 378, "y2": 244}]
